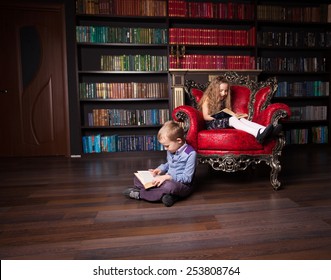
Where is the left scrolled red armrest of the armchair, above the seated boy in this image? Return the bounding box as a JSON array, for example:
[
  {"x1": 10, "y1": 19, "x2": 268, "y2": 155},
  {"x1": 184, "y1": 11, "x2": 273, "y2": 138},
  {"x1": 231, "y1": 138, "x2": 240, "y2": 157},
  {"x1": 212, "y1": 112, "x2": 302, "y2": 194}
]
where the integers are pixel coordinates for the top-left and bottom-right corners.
[{"x1": 172, "y1": 105, "x2": 206, "y2": 149}]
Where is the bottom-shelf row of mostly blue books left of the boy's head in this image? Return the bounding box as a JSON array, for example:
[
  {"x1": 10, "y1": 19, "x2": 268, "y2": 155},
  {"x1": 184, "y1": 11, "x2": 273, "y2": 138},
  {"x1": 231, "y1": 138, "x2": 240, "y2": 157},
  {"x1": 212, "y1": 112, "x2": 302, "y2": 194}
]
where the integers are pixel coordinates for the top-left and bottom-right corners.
[{"x1": 82, "y1": 134, "x2": 164, "y2": 154}]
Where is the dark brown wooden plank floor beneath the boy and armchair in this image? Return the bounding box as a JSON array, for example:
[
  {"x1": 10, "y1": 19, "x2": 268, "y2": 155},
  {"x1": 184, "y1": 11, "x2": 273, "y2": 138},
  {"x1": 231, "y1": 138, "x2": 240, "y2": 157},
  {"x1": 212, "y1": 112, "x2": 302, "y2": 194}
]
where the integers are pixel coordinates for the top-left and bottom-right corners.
[{"x1": 0, "y1": 146, "x2": 331, "y2": 260}]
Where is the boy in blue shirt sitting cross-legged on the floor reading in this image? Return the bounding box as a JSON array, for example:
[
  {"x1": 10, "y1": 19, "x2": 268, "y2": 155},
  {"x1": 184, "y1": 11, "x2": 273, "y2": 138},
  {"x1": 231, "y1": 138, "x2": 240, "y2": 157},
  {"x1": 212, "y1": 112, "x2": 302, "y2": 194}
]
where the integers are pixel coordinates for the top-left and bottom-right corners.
[{"x1": 123, "y1": 121, "x2": 197, "y2": 207}]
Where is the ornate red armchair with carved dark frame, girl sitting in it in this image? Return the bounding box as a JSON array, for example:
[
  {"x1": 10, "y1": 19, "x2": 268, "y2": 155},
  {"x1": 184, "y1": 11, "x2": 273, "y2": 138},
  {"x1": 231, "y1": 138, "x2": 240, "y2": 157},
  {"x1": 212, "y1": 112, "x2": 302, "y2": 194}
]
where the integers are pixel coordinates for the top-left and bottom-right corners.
[{"x1": 172, "y1": 72, "x2": 291, "y2": 190}]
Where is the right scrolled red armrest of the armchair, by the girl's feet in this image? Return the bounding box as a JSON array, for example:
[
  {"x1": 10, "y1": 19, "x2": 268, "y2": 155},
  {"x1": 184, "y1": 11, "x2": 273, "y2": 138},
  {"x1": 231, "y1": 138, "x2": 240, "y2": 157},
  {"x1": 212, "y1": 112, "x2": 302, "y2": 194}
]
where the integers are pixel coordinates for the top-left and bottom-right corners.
[{"x1": 253, "y1": 103, "x2": 291, "y2": 125}]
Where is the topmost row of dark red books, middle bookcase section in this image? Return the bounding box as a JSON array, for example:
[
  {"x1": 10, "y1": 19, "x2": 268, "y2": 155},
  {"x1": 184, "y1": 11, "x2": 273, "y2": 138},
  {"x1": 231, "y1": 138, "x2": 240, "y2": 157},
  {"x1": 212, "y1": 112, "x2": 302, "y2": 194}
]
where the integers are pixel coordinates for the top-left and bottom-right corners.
[{"x1": 168, "y1": 0, "x2": 254, "y2": 20}]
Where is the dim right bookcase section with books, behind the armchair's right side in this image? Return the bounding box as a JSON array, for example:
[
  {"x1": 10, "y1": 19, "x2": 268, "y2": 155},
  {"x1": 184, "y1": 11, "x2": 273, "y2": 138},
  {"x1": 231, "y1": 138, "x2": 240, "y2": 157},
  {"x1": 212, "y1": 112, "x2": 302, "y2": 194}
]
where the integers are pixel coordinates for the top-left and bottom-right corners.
[{"x1": 257, "y1": 1, "x2": 331, "y2": 144}]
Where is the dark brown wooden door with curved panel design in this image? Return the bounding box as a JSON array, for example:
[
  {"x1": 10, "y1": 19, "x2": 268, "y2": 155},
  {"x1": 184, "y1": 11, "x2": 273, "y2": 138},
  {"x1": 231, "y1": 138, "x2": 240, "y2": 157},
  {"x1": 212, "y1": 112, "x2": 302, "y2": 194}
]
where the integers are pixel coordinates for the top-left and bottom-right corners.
[{"x1": 0, "y1": 4, "x2": 70, "y2": 156}]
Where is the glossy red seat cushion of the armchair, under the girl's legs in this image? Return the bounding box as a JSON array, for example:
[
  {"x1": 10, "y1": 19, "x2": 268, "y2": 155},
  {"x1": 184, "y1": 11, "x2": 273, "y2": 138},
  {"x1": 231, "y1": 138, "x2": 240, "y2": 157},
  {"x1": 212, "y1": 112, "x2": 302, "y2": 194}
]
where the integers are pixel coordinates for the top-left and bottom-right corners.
[{"x1": 198, "y1": 128, "x2": 263, "y2": 151}]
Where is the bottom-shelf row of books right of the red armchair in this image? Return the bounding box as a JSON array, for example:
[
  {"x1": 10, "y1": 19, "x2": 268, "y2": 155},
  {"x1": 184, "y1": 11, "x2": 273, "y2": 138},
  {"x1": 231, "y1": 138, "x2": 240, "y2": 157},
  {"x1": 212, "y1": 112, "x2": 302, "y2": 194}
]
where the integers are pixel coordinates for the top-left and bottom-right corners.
[{"x1": 285, "y1": 126, "x2": 329, "y2": 144}]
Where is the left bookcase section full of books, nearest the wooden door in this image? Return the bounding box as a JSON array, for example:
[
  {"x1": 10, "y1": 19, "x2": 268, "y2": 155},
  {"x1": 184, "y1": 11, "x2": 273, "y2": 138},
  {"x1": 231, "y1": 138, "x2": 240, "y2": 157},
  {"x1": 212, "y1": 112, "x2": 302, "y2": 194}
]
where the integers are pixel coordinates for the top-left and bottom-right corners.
[{"x1": 76, "y1": 0, "x2": 170, "y2": 153}]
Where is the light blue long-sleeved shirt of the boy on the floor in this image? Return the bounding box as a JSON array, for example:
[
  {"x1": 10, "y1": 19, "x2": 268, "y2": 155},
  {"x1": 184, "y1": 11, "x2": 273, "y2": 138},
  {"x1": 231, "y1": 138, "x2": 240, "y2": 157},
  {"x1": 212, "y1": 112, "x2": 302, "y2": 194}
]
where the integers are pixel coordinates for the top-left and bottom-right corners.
[{"x1": 157, "y1": 143, "x2": 197, "y2": 184}]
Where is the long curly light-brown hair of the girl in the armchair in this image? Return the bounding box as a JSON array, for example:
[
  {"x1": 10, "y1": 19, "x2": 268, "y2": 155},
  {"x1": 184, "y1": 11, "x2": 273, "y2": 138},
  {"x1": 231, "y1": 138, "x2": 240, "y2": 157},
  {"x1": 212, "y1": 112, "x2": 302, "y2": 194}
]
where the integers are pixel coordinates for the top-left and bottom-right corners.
[{"x1": 198, "y1": 76, "x2": 232, "y2": 115}]
